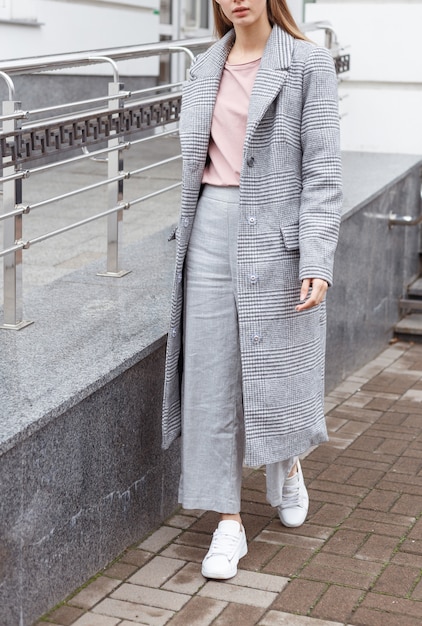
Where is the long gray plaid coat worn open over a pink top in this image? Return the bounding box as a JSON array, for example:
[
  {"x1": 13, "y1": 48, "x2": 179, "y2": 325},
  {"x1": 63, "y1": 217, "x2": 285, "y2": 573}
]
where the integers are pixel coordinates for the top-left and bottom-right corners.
[{"x1": 163, "y1": 26, "x2": 342, "y2": 466}]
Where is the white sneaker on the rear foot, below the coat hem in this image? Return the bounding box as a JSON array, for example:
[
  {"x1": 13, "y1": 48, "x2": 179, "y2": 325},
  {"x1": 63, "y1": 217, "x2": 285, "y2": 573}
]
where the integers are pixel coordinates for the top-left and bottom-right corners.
[{"x1": 277, "y1": 460, "x2": 309, "y2": 528}]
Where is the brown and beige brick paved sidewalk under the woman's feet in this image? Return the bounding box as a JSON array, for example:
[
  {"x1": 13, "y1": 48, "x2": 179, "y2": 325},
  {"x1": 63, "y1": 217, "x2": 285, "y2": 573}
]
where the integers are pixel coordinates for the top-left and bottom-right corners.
[{"x1": 36, "y1": 343, "x2": 422, "y2": 626}]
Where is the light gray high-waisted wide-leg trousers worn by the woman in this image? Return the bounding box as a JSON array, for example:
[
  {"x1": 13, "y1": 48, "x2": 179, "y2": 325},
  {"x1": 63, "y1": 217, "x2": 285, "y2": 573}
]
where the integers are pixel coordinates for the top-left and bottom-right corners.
[{"x1": 179, "y1": 185, "x2": 296, "y2": 513}]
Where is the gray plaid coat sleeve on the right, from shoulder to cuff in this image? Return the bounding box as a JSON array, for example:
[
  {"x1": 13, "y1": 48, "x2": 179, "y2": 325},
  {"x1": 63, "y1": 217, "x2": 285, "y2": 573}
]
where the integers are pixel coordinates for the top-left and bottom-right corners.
[{"x1": 299, "y1": 47, "x2": 343, "y2": 285}]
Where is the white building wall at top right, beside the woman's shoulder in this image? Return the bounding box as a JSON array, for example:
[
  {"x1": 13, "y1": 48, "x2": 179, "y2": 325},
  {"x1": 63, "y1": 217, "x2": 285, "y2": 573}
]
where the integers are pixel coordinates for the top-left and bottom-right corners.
[{"x1": 306, "y1": 0, "x2": 422, "y2": 154}]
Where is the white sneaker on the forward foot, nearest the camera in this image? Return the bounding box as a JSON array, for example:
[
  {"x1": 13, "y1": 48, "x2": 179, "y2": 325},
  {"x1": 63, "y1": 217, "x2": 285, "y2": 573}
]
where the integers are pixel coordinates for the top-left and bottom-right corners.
[{"x1": 202, "y1": 520, "x2": 248, "y2": 580}]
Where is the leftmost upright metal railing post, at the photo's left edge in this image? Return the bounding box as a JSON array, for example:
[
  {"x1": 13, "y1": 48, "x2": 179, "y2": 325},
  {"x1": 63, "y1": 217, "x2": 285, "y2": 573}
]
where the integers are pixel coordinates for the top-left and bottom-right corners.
[{"x1": 0, "y1": 91, "x2": 32, "y2": 330}]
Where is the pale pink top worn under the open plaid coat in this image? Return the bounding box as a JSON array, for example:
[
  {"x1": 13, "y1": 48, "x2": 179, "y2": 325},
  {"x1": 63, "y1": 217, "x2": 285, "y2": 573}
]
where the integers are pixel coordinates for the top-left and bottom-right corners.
[{"x1": 202, "y1": 59, "x2": 261, "y2": 187}]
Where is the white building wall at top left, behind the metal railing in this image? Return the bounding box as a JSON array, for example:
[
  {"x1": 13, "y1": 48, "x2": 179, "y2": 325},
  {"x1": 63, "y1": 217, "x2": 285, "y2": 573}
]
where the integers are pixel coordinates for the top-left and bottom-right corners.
[{"x1": 0, "y1": 0, "x2": 160, "y2": 76}]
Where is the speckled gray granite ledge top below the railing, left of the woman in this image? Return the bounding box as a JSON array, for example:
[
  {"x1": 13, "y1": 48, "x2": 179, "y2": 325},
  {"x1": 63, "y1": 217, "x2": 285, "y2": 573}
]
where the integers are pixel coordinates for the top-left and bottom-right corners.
[{"x1": 0, "y1": 224, "x2": 175, "y2": 454}]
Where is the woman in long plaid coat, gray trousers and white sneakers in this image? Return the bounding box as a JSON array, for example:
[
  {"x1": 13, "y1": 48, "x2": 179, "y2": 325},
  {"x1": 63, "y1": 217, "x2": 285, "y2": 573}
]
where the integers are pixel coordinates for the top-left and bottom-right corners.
[{"x1": 163, "y1": 0, "x2": 341, "y2": 579}]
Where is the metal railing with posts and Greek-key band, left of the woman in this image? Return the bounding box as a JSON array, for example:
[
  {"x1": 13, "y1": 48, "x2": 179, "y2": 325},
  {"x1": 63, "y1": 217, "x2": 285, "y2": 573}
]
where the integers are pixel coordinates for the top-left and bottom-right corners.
[{"x1": 0, "y1": 39, "x2": 195, "y2": 330}]
